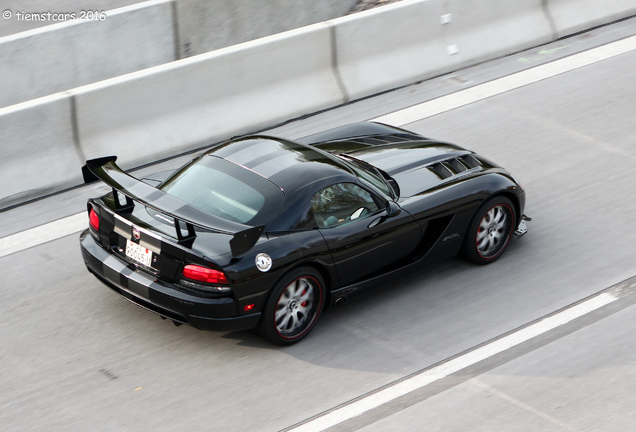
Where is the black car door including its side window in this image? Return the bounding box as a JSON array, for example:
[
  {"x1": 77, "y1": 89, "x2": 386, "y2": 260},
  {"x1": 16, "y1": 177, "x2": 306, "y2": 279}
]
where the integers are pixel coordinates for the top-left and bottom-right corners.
[{"x1": 312, "y1": 183, "x2": 421, "y2": 286}]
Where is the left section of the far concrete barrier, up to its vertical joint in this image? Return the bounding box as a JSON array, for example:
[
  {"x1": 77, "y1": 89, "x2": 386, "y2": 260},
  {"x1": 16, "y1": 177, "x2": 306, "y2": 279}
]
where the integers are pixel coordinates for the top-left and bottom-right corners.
[{"x1": 0, "y1": 0, "x2": 176, "y2": 107}]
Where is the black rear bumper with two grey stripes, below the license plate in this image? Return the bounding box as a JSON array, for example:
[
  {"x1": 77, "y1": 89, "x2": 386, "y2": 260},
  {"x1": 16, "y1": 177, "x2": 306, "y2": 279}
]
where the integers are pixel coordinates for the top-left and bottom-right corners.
[{"x1": 80, "y1": 230, "x2": 261, "y2": 331}]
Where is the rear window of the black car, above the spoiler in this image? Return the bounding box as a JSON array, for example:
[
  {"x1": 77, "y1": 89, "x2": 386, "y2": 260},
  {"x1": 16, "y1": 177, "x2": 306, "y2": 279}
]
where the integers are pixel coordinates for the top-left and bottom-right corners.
[{"x1": 159, "y1": 155, "x2": 285, "y2": 230}]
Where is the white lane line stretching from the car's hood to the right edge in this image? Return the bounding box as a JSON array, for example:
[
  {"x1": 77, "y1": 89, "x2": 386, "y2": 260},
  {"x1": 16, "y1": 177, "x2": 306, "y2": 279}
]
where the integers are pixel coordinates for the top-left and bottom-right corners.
[{"x1": 372, "y1": 36, "x2": 636, "y2": 126}]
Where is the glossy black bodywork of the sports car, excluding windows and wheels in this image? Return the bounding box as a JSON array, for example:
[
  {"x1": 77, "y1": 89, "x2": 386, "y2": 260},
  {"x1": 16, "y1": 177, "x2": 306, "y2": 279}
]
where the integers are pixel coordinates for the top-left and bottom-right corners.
[{"x1": 81, "y1": 123, "x2": 525, "y2": 330}]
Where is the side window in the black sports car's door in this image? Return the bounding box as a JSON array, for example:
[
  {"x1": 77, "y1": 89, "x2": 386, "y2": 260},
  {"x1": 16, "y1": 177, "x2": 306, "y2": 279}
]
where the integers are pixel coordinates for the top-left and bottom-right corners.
[{"x1": 311, "y1": 183, "x2": 380, "y2": 228}]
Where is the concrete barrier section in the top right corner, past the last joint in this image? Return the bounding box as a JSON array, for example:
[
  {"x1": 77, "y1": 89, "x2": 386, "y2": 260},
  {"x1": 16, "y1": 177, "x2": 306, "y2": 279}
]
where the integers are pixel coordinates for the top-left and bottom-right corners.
[{"x1": 548, "y1": 0, "x2": 636, "y2": 37}]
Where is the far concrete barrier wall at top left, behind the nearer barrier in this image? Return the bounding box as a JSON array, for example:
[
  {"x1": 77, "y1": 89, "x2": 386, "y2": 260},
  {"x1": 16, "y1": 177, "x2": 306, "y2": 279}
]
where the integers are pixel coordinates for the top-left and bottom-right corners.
[{"x1": 0, "y1": 0, "x2": 357, "y2": 108}]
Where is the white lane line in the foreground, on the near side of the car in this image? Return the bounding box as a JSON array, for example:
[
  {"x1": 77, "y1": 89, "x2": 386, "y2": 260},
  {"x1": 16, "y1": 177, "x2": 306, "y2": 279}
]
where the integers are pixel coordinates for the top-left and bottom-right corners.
[{"x1": 289, "y1": 292, "x2": 618, "y2": 432}]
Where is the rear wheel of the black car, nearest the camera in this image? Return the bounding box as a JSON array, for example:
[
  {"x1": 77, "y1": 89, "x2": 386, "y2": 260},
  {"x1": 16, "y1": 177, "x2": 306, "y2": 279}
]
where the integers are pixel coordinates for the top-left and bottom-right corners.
[{"x1": 257, "y1": 267, "x2": 325, "y2": 345}]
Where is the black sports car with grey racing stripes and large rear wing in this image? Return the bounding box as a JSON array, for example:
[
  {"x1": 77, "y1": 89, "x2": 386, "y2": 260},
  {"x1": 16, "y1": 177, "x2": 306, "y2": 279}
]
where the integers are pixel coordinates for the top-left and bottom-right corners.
[{"x1": 80, "y1": 123, "x2": 527, "y2": 345}]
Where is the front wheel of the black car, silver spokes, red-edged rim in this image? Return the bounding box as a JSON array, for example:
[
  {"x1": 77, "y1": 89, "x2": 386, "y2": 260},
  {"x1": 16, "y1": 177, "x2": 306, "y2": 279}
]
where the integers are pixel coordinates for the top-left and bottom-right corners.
[{"x1": 463, "y1": 196, "x2": 517, "y2": 264}]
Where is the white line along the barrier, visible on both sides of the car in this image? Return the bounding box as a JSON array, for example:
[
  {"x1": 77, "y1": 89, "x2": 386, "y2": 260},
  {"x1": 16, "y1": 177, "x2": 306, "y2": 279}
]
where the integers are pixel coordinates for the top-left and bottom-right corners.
[{"x1": 0, "y1": 36, "x2": 636, "y2": 258}]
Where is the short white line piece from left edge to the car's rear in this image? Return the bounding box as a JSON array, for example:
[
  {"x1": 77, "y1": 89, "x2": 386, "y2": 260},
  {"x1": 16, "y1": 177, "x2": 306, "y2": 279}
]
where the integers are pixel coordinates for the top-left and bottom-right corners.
[{"x1": 0, "y1": 212, "x2": 88, "y2": 258}]
